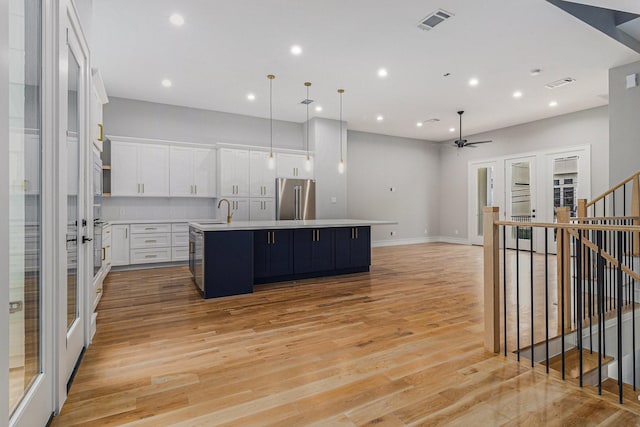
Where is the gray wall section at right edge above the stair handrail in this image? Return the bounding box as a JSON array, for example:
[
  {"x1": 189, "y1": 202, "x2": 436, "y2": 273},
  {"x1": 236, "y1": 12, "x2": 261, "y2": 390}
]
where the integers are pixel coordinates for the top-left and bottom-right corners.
[{"x1": 609, "y1": 62, "x2": 640, "y2": 185}]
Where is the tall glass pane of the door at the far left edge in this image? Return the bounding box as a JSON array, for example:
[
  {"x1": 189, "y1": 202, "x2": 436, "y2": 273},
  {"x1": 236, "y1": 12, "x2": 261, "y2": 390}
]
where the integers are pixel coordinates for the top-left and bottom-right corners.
[{"x1": 5, "y1": 0, "x2": 42, "y2": 414}]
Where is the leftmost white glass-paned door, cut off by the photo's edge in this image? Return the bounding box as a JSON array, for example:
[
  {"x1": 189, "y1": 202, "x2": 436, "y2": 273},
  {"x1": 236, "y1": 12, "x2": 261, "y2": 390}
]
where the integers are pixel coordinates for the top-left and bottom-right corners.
[{"x1": 0, "y1": 1, "x2": 57, "y2": 426}]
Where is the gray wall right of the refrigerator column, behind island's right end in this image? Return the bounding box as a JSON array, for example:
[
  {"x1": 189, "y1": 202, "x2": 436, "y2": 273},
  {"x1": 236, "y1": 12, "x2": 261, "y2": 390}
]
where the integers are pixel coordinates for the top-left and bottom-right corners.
[{"x1": 346, "y1": 131, "x2": 440, "y2": 243}]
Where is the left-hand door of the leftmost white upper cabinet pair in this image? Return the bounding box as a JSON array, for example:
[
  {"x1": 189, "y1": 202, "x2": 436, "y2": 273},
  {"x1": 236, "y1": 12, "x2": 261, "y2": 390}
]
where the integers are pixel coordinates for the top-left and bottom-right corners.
[{"x1": 111, "y1": 141, "x2": 140, "y2": 196}]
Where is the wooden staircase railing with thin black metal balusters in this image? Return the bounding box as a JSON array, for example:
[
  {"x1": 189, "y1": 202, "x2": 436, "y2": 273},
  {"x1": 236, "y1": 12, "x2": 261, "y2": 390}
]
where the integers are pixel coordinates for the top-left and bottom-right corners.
[{"x1": 484, "y1": 209, "x2": 640, "y2": 403}]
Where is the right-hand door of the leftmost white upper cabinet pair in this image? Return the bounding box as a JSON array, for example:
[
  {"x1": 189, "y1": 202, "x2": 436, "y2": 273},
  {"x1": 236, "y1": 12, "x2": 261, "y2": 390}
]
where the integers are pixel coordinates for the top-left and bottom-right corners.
[{"x1": 138, "y1": 144, "x2": 169, "y2": 197}]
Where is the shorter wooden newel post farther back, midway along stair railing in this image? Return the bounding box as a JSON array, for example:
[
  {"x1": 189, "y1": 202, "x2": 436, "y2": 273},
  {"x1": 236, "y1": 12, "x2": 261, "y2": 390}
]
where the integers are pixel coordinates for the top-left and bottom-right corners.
[{"x1": 556, "y1": 206, "x2": 571, "y2": 333}]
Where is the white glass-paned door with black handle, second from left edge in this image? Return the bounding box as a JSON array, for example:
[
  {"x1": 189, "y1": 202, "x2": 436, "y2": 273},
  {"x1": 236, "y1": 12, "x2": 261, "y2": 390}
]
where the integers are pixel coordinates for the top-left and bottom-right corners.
[{"x1": 57, "y1": 3, "x2": 93, "y2": 414}]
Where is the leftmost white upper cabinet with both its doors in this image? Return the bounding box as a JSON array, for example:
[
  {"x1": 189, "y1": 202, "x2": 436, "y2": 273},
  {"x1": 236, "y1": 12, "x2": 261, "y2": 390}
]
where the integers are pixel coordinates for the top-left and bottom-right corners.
[{"x1": 111, "y1": 139, "x2": 169, "y2": 197}]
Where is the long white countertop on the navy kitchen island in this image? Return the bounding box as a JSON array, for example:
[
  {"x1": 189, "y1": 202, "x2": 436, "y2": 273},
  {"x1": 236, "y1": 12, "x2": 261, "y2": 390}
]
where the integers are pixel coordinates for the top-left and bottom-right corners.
[{"x1": 189, "y1": 219, "x2": 397, "y2": 231}]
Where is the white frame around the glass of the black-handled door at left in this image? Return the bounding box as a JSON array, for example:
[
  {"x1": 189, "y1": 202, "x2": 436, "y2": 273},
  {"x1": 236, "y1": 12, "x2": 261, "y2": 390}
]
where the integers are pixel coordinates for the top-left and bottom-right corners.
[{"x1": 54, "y1": 0, "x2": 93, "y2": 412}]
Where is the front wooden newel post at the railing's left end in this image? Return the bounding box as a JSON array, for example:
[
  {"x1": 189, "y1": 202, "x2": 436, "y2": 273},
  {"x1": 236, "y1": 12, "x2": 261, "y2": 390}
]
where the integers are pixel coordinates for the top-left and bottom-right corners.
[{"x1": 483, "y1": 206, "x2": 500, "y2": 353}]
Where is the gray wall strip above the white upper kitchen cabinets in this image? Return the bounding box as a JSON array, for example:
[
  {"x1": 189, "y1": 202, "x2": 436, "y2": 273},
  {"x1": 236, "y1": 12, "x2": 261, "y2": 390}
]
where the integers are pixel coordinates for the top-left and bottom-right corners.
[{"x1": 104, "y1": 97, "x2": 304, "y2": 150}]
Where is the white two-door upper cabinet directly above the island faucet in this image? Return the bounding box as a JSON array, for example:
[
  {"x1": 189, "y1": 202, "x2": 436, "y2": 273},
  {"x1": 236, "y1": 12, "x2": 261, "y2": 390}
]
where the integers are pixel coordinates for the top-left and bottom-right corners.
[{"x1": 218, "y1": 148, "x2": 250, "y2": 198}]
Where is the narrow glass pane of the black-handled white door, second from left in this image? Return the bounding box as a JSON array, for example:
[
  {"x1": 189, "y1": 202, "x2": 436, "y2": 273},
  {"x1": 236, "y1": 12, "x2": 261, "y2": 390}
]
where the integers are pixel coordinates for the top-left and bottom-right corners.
[{"x1": 67, "y1": 48, "x2": 81, "y2": 330}]
